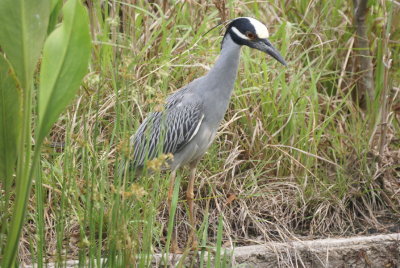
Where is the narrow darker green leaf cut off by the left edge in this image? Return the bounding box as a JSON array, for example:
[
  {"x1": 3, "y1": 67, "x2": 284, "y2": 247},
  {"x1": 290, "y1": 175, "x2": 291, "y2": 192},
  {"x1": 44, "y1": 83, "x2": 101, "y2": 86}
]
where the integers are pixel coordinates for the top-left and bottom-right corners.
[{"x1": 0, "y1": 54, "x2": 21, "y2": 188}]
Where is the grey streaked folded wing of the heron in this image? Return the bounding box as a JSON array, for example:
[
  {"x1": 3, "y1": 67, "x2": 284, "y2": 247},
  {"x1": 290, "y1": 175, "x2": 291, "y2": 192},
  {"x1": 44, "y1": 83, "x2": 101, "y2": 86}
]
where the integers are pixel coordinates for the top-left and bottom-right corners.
[{"x1": 132, "y1": 99, "x2": 204, "y2": 167}]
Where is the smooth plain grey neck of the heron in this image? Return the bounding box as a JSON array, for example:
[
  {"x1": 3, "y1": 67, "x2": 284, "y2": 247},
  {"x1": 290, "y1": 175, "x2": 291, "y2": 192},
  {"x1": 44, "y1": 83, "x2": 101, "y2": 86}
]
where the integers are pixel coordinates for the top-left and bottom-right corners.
[{"x1": 207, "y1": 34, "x2": 240, "y2": 96}]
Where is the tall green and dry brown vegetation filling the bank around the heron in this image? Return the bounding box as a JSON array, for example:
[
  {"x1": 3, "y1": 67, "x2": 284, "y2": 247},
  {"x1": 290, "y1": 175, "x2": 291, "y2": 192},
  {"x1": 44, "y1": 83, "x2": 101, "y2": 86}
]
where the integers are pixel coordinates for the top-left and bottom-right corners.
[{"x1": 0, "y1": 0, "x2": 400, "y2": 267}]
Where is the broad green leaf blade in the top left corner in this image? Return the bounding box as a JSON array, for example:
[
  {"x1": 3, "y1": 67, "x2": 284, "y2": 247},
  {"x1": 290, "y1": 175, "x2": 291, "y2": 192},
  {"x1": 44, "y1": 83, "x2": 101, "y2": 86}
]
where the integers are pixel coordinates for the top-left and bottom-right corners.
[{"x1": 0, "y1": 0, "x2": 50, "y2": 87}]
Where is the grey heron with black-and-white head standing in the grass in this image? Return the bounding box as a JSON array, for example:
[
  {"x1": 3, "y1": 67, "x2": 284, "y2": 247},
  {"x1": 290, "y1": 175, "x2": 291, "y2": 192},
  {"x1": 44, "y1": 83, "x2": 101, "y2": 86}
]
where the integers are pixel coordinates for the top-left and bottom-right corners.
[{"x1": 131, "y1": 17, "x2": 286, "y2": 251}]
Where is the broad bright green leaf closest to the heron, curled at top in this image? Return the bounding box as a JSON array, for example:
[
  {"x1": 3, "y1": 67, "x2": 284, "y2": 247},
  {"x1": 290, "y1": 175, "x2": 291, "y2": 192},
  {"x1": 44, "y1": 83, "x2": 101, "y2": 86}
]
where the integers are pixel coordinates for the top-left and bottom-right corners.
[{"x1": 37, "y1": 0, "x2": 91, "y2": 144}]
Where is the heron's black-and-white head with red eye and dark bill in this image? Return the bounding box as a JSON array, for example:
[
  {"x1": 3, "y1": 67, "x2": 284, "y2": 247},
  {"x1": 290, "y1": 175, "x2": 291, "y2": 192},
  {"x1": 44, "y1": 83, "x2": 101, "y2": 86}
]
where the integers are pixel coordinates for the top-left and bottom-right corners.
[{"x1": 225, "y1": 17, "x2": 286, "y2": 66}]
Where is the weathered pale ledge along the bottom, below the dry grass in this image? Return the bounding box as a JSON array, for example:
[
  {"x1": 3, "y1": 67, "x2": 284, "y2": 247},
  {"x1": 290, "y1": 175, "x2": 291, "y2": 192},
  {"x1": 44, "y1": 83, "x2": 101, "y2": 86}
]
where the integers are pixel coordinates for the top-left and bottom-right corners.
[{"x1": 22, "y1": 233, "x2": 400, "y2": 268}]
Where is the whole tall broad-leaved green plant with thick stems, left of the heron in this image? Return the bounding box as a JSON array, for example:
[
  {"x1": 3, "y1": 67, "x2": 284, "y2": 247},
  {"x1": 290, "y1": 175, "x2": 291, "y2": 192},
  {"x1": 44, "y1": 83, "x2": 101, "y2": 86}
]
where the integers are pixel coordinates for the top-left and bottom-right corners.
[{"x1": 0, "y1": 0, "x2": 91, "y2": 267}]
